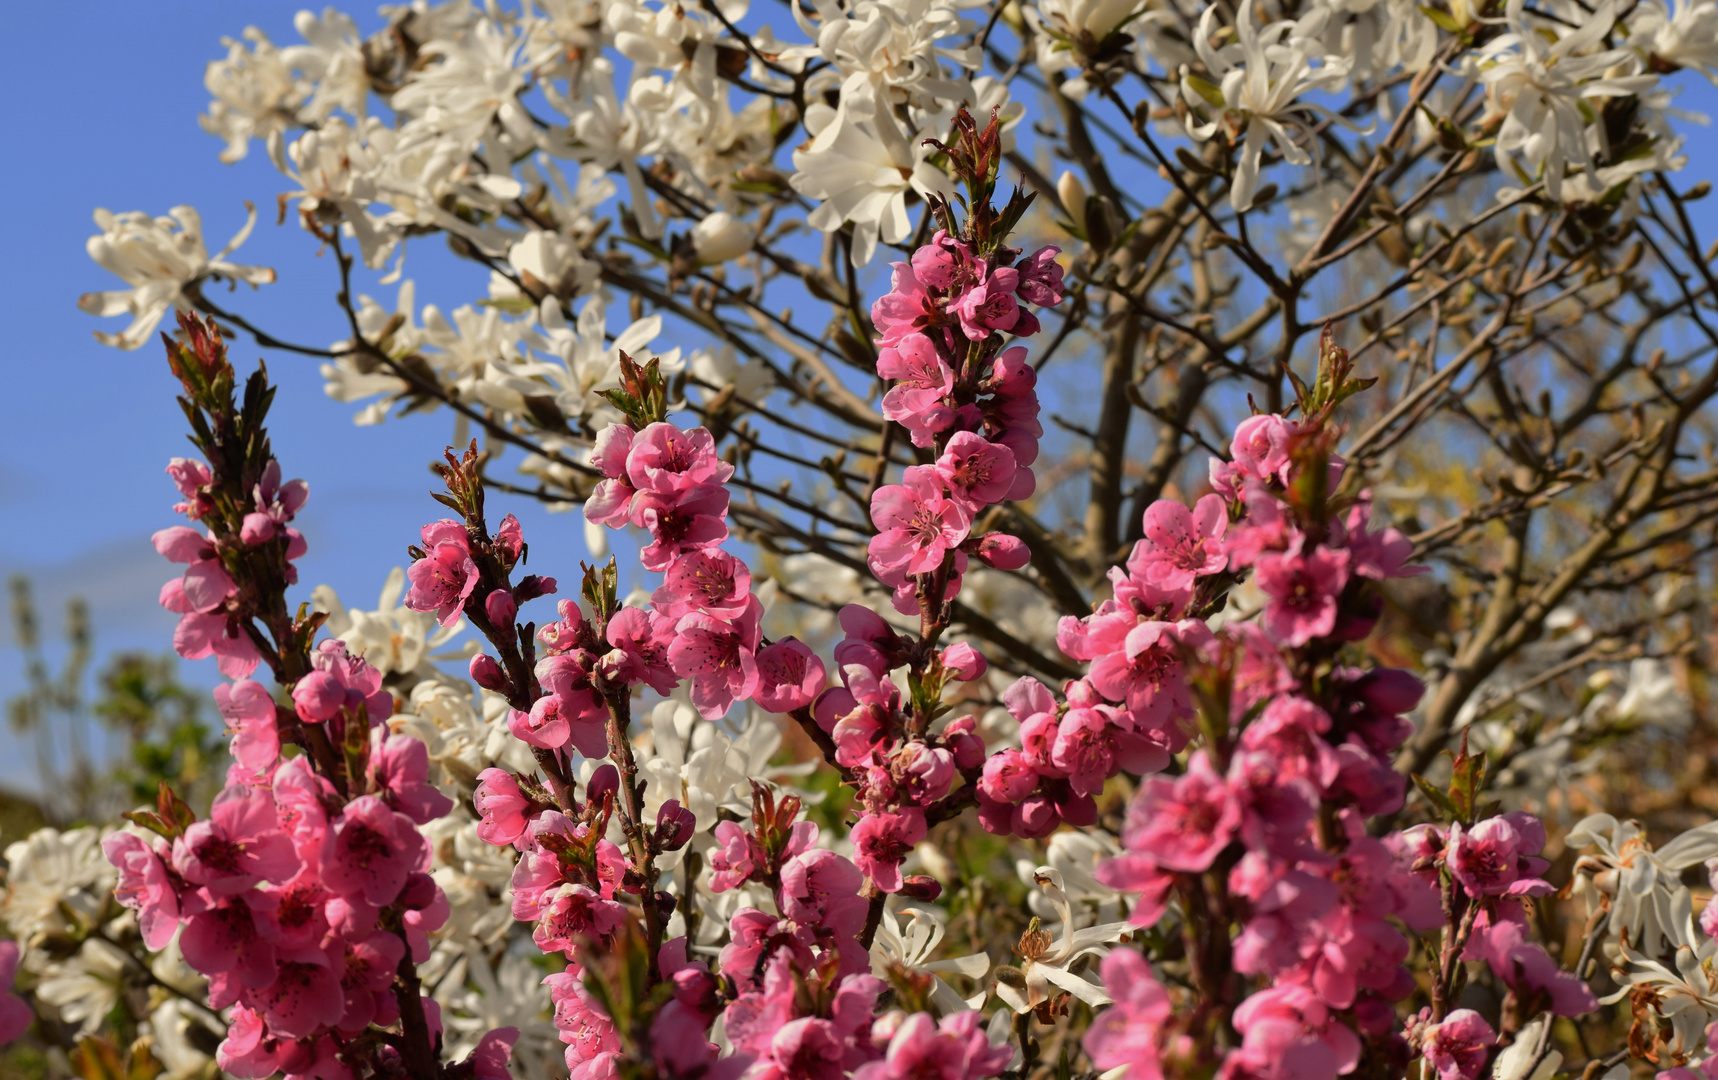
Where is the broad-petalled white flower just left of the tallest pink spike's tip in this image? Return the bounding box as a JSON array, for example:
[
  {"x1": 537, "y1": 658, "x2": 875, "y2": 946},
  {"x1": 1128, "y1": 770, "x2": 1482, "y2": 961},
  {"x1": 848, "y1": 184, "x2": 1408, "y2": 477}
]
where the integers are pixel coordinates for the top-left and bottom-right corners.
[{"x1": 792, "y1": 101, "x2": 953, "y2": 266}]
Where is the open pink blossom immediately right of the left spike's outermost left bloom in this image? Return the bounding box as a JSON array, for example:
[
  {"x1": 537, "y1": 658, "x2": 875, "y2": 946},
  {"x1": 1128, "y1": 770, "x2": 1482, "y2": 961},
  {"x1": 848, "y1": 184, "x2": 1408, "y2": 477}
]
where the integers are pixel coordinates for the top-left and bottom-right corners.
[{"x1": 174, "y1": 785, "x2": 299, "y2": 896}]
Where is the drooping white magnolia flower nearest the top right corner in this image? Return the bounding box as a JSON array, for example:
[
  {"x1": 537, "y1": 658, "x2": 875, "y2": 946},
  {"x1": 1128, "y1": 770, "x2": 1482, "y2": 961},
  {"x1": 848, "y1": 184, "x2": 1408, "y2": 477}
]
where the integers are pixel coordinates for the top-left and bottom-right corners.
[{"x1": 1476, "y1": 0, "x2": 1658, "y2": 199}]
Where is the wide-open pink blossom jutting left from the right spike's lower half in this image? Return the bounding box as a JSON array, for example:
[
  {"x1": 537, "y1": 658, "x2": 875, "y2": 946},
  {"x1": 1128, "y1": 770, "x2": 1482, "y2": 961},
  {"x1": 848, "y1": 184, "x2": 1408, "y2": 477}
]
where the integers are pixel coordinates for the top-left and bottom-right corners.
[{"x1": 1122, "y1": 750, "x2": 1240, "y2": 874}]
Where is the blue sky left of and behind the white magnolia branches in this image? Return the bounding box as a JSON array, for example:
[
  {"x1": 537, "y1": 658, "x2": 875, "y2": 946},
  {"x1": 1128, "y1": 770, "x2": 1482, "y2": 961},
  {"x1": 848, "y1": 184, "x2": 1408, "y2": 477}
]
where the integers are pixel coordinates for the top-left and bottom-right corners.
[{"x1": 0, "y1": 0, "x2": 1718, "y2": 800}]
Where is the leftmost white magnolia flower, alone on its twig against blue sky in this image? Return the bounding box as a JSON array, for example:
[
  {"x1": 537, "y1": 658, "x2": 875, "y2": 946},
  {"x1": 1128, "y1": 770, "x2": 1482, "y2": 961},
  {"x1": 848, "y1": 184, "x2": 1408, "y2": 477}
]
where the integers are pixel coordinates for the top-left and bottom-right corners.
[{"x1": 77, "y1": 206, "x2": 275, "y2": 349}]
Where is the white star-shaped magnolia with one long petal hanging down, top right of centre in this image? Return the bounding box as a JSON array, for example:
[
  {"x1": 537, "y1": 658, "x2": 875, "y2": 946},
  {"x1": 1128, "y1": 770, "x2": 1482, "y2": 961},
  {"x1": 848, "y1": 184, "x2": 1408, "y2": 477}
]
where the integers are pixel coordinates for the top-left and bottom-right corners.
[{"x1": 1182, "y1": 0, "x2": 1352, "y2": 211}]
